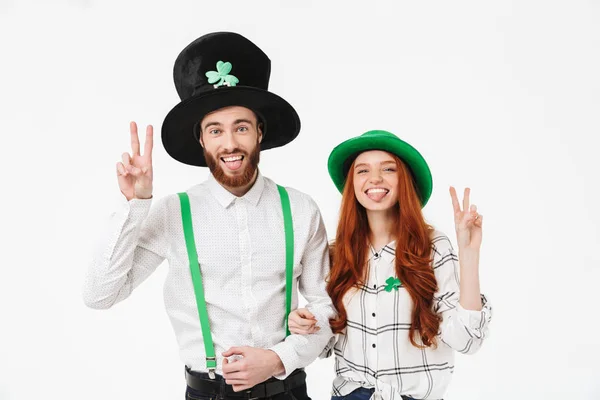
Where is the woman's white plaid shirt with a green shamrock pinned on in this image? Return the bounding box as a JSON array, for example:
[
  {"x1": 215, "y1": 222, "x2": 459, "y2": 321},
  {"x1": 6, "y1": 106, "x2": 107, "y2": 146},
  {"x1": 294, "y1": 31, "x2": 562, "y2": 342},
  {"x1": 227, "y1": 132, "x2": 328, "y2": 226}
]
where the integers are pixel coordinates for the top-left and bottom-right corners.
[{"x1": 323, "y1": 232, "x2": 492, "y2": 400}]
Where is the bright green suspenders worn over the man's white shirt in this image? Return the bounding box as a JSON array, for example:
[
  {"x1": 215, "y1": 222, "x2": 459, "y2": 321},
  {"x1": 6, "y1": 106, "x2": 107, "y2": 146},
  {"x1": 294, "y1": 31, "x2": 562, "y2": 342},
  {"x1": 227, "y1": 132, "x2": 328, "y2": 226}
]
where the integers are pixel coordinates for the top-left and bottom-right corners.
[{"x1": 178, "y1": 185, "x2": 294, "y2": 379}]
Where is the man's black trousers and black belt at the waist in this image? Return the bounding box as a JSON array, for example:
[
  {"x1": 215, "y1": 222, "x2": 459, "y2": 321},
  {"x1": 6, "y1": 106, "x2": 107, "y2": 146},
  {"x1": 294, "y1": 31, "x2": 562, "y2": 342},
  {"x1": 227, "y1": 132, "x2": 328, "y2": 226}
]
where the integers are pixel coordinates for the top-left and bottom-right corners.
[{"x1": 185, "y1": 366, "x2": 306, "y2": 399}]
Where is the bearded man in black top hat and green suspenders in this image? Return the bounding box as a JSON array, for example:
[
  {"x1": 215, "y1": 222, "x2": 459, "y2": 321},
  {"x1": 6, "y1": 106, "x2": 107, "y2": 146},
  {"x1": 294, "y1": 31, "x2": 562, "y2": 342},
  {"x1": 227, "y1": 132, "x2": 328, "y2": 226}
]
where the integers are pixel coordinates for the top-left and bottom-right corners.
[{"x1": 84, "y1": 32, "x2": 334, "y2": 400}]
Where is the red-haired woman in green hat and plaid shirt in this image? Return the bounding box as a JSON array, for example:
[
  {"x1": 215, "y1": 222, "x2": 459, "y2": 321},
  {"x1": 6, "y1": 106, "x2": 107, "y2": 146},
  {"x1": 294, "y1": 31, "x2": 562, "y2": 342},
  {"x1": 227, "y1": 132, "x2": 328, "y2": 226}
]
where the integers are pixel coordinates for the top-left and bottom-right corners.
[{"x1": 289, "y1": 131, "x2": 491, "y2": 400}]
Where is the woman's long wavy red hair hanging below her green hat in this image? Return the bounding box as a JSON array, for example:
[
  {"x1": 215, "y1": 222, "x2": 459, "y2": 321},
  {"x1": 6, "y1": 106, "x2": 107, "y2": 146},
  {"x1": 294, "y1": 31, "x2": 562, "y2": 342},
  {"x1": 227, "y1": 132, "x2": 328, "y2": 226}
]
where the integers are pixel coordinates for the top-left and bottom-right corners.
[{"x1": 327, "y1": 154, "x2": 441, "y2": 348}]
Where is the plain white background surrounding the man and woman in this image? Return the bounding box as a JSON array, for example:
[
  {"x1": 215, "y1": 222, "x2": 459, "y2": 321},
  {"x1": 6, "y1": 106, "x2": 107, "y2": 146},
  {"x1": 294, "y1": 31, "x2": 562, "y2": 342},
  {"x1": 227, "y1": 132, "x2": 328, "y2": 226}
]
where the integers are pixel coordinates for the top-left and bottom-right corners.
[{"x1": 0, "y1": 0, "x2": 600, "y2": 400}]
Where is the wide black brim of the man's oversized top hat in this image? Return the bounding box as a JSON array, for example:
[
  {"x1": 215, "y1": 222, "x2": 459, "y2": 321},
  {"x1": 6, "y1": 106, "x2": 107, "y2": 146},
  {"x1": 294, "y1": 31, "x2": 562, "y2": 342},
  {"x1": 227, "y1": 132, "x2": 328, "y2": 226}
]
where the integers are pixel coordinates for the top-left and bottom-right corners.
[{"x1": 161, "y1": 86, "x2": 300, "y2": 167}]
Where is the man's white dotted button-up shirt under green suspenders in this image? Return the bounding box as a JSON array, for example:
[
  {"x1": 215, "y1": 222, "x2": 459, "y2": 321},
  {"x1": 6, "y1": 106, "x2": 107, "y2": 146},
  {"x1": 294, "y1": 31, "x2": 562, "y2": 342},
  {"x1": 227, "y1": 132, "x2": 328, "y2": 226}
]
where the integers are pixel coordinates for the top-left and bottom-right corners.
[{"x1": 84, "y1": 173, "x2": 334, "y2": 379}]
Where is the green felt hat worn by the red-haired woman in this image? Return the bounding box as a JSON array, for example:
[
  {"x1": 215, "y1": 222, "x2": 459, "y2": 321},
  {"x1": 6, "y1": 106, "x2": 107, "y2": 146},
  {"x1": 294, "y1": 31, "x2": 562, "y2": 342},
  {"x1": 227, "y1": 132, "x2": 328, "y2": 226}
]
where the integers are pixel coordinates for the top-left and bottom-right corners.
[{"x1": 327, "y1": 131, "x2": 433, "y2": 207}]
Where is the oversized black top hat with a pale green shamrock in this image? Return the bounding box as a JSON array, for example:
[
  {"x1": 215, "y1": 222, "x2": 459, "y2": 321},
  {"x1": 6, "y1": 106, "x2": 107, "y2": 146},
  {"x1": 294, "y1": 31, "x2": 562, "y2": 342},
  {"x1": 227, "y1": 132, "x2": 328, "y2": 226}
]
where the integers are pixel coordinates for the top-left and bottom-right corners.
[{"x1": 162, "y1": 32, "x2": 300, "y2": 167}]
